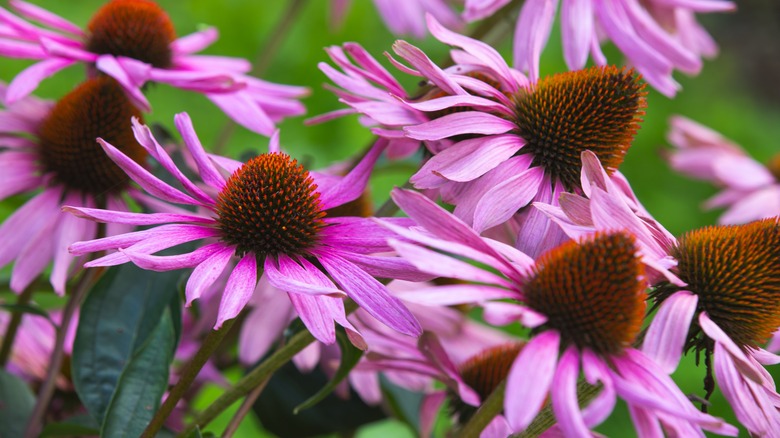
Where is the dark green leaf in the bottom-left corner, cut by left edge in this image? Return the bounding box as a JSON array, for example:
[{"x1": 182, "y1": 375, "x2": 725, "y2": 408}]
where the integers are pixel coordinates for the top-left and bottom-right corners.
[{"x1": 0, "y1": 370, "x2": 35, "y2": 438}]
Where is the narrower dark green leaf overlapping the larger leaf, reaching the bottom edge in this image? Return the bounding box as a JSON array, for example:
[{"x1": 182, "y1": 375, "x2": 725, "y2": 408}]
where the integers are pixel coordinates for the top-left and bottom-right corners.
[{"x1": 100, "y1": 309, "x2": 176, "y2": 438}]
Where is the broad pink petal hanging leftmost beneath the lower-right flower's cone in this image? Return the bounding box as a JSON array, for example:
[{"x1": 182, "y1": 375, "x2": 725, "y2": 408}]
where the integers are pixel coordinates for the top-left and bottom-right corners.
[{"x1": 504, "y1": 330, "x2": 561, "y2": 432}]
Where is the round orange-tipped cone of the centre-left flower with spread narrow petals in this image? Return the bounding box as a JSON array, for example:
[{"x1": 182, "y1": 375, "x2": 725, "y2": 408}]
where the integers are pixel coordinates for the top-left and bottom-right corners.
[{"x1": 217, "y1": 153, "x2": 325, "y2": 257}]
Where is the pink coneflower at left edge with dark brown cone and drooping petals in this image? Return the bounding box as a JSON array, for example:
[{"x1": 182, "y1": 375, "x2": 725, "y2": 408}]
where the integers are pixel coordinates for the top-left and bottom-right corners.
[{"x1": 0, "y1": 76, "x2": 146, "y2": 295}]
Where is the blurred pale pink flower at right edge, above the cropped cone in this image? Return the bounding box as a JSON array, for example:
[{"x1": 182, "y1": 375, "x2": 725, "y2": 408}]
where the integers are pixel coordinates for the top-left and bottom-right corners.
[{"x1": 666, "y1": 116, "x2": 780, "y2": 224}]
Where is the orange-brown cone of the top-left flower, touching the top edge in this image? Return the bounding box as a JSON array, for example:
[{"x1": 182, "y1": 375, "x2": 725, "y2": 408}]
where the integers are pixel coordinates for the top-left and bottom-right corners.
[{"x1": 86, "y1": 0, "x2": 176, "y2": 68}]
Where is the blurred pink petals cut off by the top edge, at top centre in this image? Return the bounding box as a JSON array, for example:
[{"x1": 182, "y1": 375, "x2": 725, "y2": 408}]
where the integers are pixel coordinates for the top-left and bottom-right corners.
[{"x1": 331, "y1": 0, "x2": 463, "y2": 38}]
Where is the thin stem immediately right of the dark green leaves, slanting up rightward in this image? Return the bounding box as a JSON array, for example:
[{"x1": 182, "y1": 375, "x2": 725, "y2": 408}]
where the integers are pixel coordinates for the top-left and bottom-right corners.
[{"x1": 141, "y1": 318, "x2": 236, "y2": 438}]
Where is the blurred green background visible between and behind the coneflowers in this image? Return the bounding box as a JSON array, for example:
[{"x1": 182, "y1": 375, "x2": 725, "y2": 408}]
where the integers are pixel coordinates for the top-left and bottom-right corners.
[{"x1": 0, "y1": 0, "x2": 780, "y2": 437}]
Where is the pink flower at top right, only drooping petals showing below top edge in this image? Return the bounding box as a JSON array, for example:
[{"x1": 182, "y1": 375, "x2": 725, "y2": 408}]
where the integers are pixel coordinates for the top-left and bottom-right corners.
[{"x1": 508, "y1": 0, "x2": 736, "y2": 96}]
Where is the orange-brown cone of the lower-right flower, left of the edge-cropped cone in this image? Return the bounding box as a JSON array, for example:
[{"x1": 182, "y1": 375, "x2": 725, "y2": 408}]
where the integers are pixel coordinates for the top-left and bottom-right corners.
[{"x1": 523, "y1": 232, "x2": 646, "y2": 354}]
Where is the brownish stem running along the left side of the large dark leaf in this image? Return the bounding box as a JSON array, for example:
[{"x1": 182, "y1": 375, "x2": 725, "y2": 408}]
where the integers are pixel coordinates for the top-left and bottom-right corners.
[{"x1": 24, "y1": 268, "x2": 105, "y2": 438}]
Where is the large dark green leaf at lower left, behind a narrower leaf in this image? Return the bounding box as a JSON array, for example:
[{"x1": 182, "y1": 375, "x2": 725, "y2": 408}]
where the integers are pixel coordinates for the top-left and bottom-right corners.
[{"x1": 72, "y1": 263, "x2": 181, "y2": 424}]
